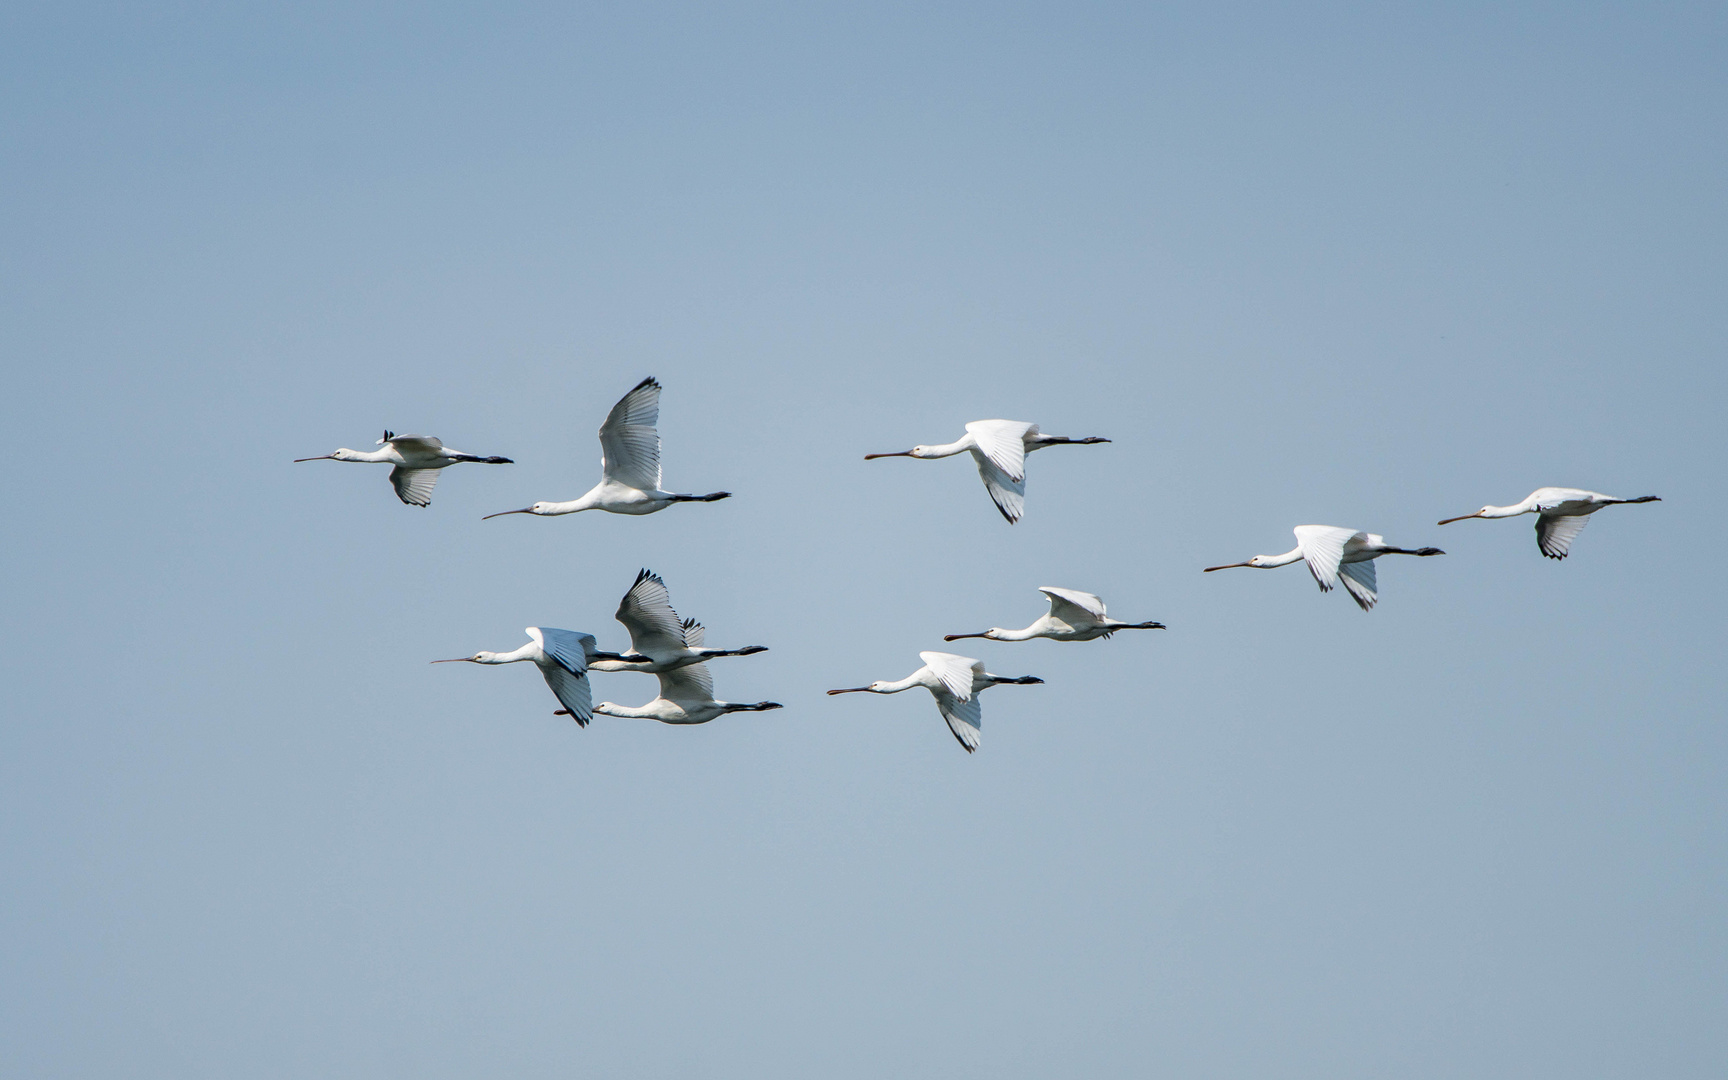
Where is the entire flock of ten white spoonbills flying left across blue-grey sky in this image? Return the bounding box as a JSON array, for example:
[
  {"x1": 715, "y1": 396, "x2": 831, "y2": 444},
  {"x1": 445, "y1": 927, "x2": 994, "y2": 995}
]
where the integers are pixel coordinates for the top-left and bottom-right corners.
[{"x1": 295, "y1": 377, "x2": 1661, "y2": 753}]
